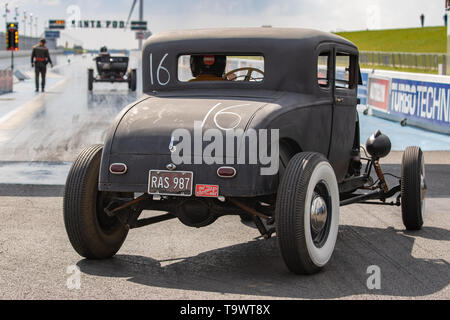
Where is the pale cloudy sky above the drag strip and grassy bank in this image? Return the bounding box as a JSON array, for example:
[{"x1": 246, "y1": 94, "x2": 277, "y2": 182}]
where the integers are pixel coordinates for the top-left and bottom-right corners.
[{"x1": 0, "y1": 0, "x2": 445, "y2": 49}]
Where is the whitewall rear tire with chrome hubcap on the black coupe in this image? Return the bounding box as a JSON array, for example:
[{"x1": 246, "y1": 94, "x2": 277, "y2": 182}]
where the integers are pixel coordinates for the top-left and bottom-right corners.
[{"x1": 275, "y1": 153, "x2": 339, "y2": 274}]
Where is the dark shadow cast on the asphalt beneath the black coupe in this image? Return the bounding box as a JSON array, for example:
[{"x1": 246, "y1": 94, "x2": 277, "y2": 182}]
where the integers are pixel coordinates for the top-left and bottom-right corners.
[{"x1": 77, "y1": 226, "x2": 450, "y2": 299}]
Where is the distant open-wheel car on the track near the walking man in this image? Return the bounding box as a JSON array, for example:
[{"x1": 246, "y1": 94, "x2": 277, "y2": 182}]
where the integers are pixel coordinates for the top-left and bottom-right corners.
[{"x1": 88, "y1": 48, "x2": 137, "y2": 92}]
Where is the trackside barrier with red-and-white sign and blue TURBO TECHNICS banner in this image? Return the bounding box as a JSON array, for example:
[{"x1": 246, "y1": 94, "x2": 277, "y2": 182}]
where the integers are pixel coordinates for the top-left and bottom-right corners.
[{"x1": 362, "y1": 70, "x2": 450, "y2": 134}]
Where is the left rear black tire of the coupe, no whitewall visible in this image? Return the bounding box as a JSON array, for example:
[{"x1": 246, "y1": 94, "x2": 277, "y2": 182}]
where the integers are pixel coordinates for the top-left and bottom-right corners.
[{"x1": 64, "y1": 145, "x2": 128, "y2": 259}]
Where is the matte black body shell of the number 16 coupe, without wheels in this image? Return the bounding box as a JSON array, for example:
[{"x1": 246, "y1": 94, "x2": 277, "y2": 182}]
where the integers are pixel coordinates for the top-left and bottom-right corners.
[{"x1": 100, "y1": 28, "x2": 359, "y2": 197}]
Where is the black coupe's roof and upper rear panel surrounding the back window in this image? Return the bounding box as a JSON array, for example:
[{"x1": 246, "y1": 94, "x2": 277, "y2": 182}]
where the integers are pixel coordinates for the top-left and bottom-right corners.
[{"x1": 143, "y1": 27, "x2": 358, "y2": 93}]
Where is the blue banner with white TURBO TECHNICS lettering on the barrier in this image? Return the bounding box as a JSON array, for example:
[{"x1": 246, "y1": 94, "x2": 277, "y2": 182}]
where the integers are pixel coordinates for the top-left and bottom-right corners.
[{"x1": 389, "y1": 78, "x2": 450, "y2": 127}]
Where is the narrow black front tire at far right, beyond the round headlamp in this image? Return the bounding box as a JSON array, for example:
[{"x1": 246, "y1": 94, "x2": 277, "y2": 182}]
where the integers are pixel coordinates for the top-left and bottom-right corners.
[{"x1": 401, "y1": 147, "x2": 426, "y2": 230}]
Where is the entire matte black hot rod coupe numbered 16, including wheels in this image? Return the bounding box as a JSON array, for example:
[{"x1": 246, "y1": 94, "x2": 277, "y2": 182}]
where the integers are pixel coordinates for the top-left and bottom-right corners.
[{"x1": 64, "y1": 28, "x2": 426, "y2": 274}]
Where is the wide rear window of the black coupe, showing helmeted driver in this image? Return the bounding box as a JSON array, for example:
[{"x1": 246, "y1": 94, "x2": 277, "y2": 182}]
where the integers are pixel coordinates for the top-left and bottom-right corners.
[{"x1": 178, "y1": 54, "x2": 264, "y2": 82}]
